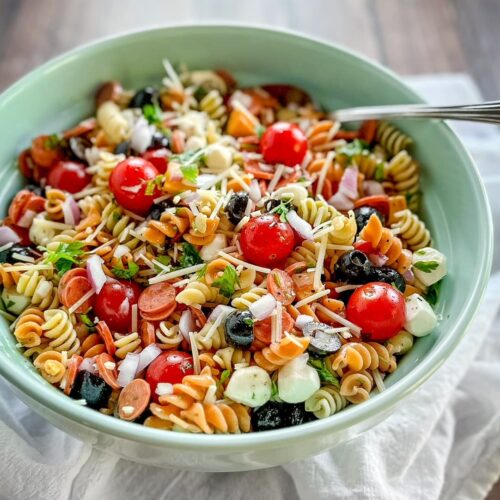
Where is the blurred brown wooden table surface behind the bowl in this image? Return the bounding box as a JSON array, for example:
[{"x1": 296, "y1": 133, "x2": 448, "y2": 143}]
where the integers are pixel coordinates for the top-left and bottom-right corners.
[{"x1": 0, "y1": 0, "x2": 500, "y2": 500}]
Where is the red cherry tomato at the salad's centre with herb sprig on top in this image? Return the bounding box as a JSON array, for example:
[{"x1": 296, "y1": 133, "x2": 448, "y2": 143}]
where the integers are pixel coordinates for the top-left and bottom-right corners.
[{"x1": 240, "y1": 214, "x2": 295, "y2": 267}]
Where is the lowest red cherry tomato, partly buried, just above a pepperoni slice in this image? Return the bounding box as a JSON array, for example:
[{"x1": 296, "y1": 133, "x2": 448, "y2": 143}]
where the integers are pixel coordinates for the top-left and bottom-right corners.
[{"x1": 146, "y1": 351, "x2": 194, "y2": 402}]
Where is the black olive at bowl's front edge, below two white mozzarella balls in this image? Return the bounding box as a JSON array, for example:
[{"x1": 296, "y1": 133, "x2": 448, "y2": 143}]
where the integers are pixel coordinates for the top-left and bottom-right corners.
[{"x1": 252, "y1": 401, "x2": 314, "y2": 432}]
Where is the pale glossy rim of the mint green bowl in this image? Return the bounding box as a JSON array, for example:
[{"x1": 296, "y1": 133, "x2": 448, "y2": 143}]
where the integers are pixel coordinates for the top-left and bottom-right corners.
[{"x1": 0, "y1": 22, "x2": 493, "y2": 451}]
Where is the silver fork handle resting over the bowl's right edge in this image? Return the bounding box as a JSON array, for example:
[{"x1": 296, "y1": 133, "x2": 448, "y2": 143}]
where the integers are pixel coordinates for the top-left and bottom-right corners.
[{"x1": 331, "y1": 101, "x2": 500, "y2": 124}]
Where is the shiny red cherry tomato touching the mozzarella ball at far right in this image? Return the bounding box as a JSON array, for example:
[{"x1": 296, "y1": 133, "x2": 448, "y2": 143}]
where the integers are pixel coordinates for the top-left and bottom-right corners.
[{"x1": 346, "y1": 282, "x2": 406, "y2": 341}]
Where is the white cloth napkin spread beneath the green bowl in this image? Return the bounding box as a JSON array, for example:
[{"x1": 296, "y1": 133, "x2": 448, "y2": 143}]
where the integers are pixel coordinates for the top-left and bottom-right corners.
[{"x1": 0, "y1": 75, "x2": 500, "y2": 500}]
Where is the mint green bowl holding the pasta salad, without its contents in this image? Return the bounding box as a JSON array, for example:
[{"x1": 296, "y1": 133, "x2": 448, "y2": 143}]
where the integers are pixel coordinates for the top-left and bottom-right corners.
[{"x1": 0, "y1": 25, "x2": 493, "y2": 471}]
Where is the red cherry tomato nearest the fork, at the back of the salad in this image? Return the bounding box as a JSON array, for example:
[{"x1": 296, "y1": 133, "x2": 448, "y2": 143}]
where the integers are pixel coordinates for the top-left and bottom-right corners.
[{"x1": 260, "y1": 122, "x2": 307, "y2": 167}]
